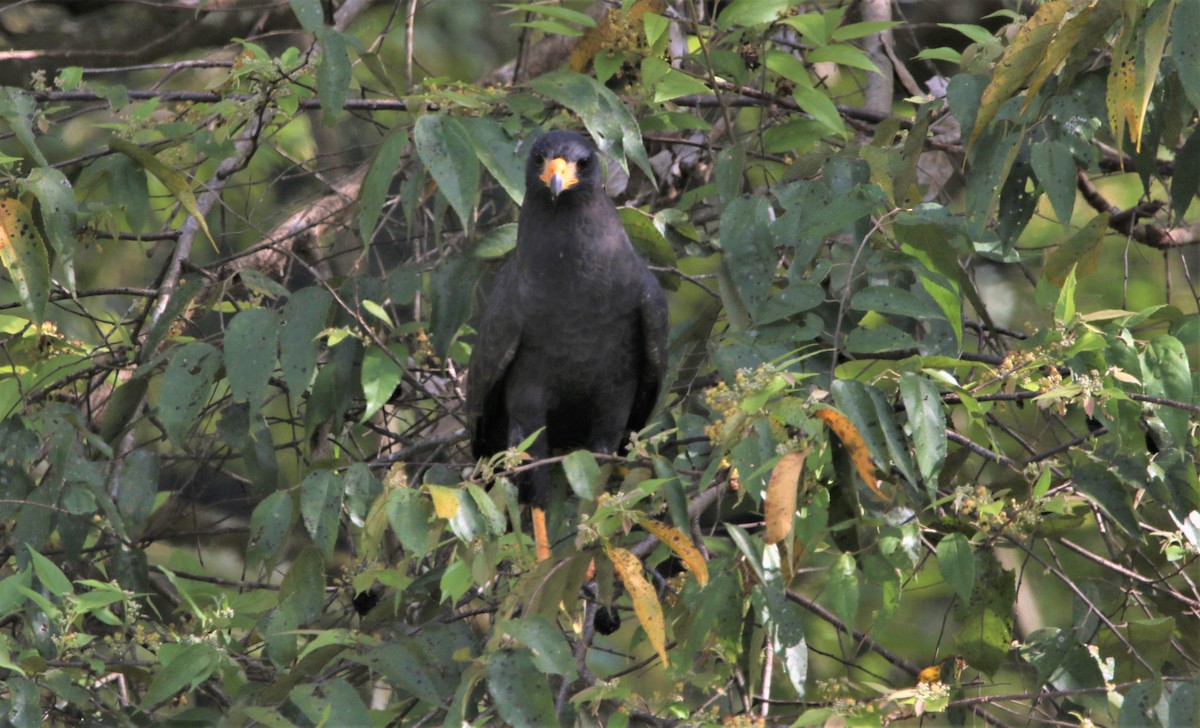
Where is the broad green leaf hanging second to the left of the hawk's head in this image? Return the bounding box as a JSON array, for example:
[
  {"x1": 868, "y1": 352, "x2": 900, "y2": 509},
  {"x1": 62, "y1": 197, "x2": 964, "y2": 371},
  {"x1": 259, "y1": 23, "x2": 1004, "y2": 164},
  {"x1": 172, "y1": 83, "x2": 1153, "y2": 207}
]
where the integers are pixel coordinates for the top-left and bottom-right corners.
[{"x1": 413, "y1": 114, "x2": 479, "y2": 229}]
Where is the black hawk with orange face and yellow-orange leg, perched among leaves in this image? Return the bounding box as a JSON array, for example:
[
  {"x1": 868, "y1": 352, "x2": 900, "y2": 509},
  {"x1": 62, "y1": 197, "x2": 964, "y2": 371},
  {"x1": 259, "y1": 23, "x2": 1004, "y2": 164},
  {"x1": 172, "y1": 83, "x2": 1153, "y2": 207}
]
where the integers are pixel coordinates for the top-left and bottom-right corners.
[{"x1": 466, "y1": 131, "x2": 667, "y2": 560}]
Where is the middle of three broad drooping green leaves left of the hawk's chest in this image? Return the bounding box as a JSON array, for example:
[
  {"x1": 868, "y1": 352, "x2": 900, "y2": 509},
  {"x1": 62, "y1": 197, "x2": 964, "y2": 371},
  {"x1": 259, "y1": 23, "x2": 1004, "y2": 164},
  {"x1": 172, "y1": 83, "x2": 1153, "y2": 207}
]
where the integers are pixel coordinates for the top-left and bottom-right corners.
[{"x1": 224, "y1": 308, "x2": 280, "y2": 414}]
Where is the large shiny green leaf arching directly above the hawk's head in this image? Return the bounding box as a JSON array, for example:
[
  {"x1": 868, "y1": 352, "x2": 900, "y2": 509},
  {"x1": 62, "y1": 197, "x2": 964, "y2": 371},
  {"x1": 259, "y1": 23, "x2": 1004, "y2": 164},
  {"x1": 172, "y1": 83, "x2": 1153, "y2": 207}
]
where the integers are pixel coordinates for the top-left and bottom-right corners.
[{"x1": 529, "y1": 71, "x2": 655, "y2": 180}]
